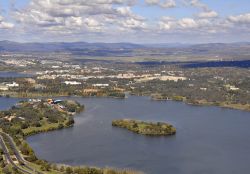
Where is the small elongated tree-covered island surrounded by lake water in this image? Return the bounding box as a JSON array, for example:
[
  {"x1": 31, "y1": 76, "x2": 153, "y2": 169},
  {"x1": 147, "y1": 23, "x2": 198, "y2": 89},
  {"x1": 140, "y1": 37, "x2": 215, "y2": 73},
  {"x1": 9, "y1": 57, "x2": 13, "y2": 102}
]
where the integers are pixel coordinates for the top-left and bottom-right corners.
[{"x1": 112, "y1": 119, "x2": 176, "y2": 136}]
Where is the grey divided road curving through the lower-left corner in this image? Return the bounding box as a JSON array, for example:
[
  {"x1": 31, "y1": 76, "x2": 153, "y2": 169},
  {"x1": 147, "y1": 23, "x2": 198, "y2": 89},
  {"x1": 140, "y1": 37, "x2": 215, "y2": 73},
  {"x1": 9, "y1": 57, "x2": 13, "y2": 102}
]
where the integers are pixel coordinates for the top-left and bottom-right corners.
[{"x1": 0, "y1": 132, "x2": 43, "y2": 174}]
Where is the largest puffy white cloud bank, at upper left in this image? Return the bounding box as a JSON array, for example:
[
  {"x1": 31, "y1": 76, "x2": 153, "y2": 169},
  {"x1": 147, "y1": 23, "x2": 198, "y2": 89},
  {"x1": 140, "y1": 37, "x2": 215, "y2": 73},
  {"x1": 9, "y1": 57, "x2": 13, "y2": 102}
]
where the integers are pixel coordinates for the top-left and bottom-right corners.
[{"x1": 13, "y1": 0, "x2": 146, "y2": 33}]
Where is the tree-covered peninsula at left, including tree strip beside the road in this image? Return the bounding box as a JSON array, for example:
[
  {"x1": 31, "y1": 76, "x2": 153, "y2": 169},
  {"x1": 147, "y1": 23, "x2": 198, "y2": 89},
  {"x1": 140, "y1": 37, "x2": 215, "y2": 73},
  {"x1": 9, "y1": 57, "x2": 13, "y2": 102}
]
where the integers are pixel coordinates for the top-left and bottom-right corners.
[{"x1": 0, "y1": 101, "x2": 84, "y2": 154}]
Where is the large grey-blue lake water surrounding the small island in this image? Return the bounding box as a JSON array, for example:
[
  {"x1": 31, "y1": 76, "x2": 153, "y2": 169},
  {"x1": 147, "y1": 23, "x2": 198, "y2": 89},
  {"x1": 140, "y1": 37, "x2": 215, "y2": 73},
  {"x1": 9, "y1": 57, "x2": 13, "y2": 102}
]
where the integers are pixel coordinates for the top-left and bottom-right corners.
[{"x1": 0, "y1": 96, "x2": 250, "y2": 174}]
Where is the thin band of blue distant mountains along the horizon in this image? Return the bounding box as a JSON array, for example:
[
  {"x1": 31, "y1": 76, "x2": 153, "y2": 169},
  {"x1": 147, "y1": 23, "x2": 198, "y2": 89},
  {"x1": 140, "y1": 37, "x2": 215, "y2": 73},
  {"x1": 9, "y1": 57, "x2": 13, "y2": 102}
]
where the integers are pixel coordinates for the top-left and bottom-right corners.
[{"x1": 0, "y1": 40, "x2": 250, "y2": 52}]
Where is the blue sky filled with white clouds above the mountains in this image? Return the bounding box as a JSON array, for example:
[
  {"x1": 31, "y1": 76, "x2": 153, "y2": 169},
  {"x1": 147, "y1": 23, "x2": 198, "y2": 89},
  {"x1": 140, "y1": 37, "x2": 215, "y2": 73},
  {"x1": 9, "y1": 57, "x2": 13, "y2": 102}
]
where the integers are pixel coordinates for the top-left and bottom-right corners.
[{"x1": 0, "y1": 0, "x2": 250, "y2": 43}]
